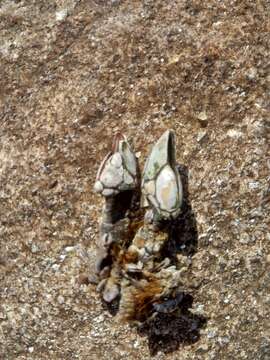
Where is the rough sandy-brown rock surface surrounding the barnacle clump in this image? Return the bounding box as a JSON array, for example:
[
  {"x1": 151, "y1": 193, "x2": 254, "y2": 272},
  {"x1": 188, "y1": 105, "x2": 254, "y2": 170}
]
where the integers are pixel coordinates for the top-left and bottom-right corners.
[{"x1": 0, "y1": 0, "x2": 270, "y2": 360}]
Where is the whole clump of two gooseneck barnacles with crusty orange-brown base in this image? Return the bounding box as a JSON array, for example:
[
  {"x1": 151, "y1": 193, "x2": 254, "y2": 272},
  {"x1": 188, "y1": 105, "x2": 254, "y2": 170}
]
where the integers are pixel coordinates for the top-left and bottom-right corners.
[{"x1": 94, "y1": 130, "x2": 186, "y2": 322}]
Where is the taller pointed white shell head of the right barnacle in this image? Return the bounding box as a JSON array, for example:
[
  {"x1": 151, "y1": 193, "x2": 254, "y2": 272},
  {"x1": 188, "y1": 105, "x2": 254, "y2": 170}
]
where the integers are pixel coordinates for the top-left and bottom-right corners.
[{"x1": 142, "y1": 130, "x2": 183, "y2": 218}]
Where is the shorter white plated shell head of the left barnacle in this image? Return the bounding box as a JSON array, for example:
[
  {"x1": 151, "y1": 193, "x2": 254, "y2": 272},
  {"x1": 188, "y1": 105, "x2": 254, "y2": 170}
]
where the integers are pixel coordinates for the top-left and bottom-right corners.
[{"x1": 94, "y1": 134, "x2": 137, "y2": 196}]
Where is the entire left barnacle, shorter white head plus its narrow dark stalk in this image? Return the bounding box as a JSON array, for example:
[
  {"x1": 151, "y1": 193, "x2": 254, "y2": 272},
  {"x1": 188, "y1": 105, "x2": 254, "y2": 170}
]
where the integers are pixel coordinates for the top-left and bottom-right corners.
[{"x1": 94, "y1": 133, "x2": 138, "y2": 302}]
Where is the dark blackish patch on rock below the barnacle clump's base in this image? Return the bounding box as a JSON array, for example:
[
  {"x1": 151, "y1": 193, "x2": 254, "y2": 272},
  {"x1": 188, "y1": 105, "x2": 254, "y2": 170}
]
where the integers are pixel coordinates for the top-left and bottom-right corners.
[{"x1": 139, "y1": 294, "x2": 206, "y2": 356}]
